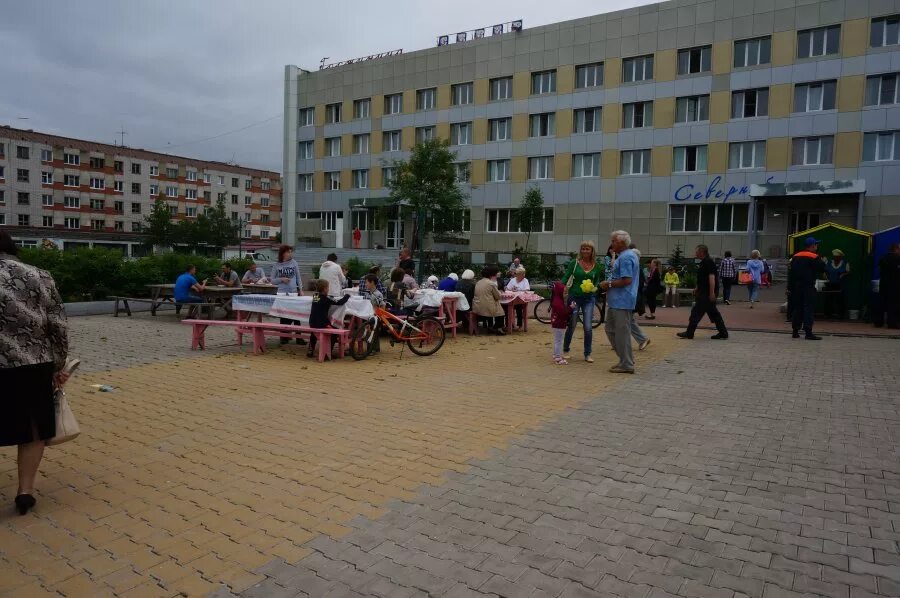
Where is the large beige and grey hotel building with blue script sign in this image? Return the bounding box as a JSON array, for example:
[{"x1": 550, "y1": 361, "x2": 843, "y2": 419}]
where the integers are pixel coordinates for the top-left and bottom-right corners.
[{"x1": 284, "y1": 0, "x2": 900, "y2": 257}]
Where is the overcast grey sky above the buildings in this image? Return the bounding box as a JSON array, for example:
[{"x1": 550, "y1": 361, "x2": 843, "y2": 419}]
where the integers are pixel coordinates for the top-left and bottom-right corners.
[{"x1": 0, "y1": 0, "x2": 648, "y2": 172}]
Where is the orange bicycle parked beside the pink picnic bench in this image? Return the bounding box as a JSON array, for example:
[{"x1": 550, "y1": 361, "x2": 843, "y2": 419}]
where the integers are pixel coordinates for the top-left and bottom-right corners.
[{"x1": 350, "y1": 307, "x2": 445, "y2": 361}]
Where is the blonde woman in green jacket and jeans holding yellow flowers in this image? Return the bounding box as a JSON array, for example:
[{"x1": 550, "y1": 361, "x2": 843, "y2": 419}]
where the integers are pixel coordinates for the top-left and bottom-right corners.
[{"x1": 563, "y1": 241, "x2": 603, "y2": 363}]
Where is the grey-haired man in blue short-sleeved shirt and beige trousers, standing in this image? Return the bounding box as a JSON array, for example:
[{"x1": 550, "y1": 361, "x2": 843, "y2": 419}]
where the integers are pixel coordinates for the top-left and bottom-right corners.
[{"x1": 600, "y1": 230, "x2": 640, "y2": 374}]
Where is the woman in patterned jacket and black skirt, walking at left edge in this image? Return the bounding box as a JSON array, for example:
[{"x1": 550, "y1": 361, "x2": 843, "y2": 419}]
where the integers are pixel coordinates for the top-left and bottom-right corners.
[{"x1": 0, "y1": 231, "x2": 69, "y2": 515}]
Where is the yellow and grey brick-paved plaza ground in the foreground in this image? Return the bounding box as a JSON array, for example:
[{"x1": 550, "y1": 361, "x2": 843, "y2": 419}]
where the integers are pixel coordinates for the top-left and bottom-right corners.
[{"x1": 0, "y1": 316, "x2": 900, "y2": 598}]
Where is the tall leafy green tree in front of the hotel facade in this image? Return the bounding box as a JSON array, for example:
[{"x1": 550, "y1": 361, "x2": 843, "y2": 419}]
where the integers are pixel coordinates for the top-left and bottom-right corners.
[{"x1": 388, "y1": 139, "x2": 467, "y2": 272}]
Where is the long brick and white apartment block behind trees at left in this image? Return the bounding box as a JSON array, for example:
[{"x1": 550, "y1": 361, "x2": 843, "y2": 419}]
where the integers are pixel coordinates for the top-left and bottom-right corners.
[{"x1": 0, "y1": 126, "x2": 281, "y2": 254}]
